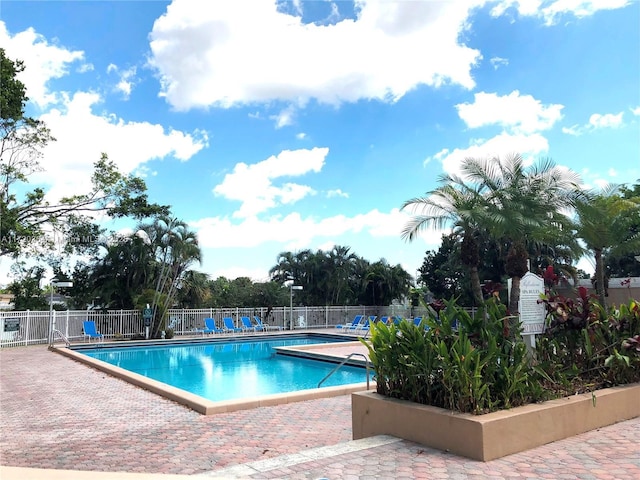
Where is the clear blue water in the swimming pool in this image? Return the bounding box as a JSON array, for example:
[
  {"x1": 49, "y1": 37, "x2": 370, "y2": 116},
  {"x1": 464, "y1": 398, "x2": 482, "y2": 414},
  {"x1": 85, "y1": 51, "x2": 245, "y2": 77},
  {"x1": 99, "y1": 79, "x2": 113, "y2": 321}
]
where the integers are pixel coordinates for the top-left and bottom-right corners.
[{"x1": 81, "y1": 337, "x2": 367, "y2": 401}]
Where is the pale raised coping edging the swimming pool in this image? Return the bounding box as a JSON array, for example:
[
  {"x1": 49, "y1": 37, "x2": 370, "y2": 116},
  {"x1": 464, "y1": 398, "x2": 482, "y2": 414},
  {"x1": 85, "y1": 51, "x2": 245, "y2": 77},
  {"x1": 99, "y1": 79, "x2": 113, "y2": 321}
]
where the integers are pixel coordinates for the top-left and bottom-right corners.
[{"x1": 49, "y1": 336, "x2": 375, "y2": 415}]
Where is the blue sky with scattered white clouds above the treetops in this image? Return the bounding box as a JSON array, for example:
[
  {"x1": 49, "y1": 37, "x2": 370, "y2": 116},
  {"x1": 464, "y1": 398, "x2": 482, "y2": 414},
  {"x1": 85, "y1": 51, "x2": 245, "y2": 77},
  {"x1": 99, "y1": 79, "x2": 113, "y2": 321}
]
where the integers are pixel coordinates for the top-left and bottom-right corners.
[{"x1": 0, "y1": 0, "x2": 640, "y2": 283}]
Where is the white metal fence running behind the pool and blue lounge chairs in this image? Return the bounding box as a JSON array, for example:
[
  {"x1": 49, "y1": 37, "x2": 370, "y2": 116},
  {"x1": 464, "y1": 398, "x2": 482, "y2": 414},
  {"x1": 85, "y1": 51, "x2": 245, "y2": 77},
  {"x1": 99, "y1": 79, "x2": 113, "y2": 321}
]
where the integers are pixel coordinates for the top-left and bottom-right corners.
[{"x1": 0, "y1": 305, "x2": 425, "y2": 348}]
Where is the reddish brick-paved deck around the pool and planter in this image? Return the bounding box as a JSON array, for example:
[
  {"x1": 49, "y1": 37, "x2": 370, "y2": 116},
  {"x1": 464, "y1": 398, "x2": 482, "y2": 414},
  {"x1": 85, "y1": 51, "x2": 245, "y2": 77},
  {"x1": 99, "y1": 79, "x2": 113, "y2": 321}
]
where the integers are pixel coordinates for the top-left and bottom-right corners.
[{"x1": 0, "y1": 336, "x2": 640, "y2": 480}]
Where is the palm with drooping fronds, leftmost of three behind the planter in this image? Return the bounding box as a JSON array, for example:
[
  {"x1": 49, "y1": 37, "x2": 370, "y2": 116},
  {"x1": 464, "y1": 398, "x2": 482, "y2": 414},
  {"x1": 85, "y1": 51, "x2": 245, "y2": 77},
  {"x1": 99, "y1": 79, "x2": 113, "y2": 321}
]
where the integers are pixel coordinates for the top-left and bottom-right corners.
[{"x1": 402, "y1": 175, "x2": 487, "y2": 305}]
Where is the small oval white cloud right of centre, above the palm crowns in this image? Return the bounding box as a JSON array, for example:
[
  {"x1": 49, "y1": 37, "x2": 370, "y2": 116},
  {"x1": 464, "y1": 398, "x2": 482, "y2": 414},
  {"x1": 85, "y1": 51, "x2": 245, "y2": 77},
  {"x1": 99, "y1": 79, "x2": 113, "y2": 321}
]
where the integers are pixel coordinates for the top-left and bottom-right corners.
[{"x1": 456, "y1": 90, "x2": 564, "y2": 133}]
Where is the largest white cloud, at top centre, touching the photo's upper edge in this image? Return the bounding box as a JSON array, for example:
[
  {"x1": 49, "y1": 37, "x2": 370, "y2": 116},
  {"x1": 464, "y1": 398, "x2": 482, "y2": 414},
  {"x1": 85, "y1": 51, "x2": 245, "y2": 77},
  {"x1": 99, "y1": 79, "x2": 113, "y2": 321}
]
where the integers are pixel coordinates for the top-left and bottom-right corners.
[{"x1": 150, "y1": 0, "x2": 484, "y2": 110}]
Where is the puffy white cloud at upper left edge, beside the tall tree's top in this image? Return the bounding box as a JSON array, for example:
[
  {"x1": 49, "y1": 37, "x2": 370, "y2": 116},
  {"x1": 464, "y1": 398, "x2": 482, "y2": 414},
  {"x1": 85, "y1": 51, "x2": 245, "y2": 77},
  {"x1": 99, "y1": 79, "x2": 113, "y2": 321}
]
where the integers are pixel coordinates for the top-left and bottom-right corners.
[{"x1": 0, "y1": 21, "x2": 84, "y2": 108}]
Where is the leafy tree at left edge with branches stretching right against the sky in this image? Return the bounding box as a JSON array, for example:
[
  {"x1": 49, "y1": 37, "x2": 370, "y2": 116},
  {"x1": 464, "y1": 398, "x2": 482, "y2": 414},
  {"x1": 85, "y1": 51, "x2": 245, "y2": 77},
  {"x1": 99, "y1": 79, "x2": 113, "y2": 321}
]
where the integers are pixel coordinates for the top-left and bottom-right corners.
[{"x1": 0, "y1": 48, "x2": 168, "y2": 256}]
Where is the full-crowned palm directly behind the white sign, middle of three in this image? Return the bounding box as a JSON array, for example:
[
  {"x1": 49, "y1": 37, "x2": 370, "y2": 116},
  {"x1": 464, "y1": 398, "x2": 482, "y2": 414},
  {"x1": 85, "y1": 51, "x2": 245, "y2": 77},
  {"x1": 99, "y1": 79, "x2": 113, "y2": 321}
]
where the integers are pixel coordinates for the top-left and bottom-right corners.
[{"x1": 462, "y1": 155, "x2": 580, "y2": 315}]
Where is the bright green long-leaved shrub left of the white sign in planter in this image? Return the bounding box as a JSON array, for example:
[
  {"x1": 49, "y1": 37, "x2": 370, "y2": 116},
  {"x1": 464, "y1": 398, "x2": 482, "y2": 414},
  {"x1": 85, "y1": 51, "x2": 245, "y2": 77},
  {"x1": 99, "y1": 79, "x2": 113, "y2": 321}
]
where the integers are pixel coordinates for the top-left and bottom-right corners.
[{"x1": 362, "y1": 300, "x2": 544, "y2": 414}]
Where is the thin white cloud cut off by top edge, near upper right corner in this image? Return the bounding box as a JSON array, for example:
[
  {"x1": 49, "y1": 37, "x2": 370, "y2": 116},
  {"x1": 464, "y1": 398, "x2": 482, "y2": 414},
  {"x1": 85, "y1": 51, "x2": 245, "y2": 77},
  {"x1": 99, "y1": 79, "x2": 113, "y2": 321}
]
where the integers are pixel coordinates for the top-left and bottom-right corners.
[{"x1": 491, "y1": 0, "x2": 631, "y2": 25}]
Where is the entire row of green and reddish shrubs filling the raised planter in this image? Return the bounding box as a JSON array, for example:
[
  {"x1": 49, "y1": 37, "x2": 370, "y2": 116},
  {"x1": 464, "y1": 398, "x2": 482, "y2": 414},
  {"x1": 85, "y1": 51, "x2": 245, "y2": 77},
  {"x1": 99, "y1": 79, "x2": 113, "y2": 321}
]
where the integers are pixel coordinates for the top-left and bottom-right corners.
[{"x1": 361, "y1": 290, "x2": 640, "y2": 414}]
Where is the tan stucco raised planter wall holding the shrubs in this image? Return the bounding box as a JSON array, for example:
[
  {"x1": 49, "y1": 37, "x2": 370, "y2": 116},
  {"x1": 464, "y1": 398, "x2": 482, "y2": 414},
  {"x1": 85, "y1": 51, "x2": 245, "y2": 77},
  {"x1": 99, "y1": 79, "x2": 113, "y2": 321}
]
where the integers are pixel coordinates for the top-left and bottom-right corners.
[{"x1": 351, "y1": 383, "x2": 640, "y2": 461}]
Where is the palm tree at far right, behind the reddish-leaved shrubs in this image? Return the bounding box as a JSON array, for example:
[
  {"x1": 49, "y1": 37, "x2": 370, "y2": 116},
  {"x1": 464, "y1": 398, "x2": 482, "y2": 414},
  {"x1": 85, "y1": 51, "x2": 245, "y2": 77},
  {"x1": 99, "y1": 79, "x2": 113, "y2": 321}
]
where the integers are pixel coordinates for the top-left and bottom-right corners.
[{"x1": 575, "y1": 185, "x2": 640, "y2": 306}]
